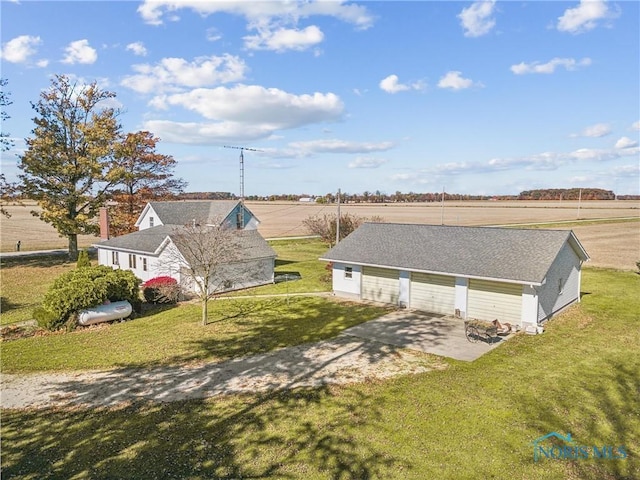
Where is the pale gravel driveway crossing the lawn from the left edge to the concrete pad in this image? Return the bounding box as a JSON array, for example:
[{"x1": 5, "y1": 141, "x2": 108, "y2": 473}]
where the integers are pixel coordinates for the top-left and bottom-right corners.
[{"x1": 0, "y1": 333, "x2": 445, "y2": 408}]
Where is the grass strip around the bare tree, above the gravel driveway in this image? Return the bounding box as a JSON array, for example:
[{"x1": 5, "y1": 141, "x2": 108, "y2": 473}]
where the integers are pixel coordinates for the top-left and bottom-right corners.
[{"x1": 1, "y1": 297, "x2": 388, "y2": 373}]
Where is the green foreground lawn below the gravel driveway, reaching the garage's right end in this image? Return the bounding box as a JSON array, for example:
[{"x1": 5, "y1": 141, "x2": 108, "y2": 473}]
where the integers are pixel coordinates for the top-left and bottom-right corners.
[{"x1": 2, "y1": 269, "x2": 640, "y2": 480}]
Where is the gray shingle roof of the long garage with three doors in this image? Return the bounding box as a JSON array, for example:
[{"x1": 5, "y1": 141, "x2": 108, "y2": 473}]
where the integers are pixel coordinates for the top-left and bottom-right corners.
[{"x1": 321, "y1": 223, "x2": 589, "y2": 283}]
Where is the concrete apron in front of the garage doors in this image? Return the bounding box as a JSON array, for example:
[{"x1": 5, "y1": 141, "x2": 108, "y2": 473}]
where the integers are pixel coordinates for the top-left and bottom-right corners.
[{"x1": 343, "y1": 310, "x2": 511, "y2": 362}]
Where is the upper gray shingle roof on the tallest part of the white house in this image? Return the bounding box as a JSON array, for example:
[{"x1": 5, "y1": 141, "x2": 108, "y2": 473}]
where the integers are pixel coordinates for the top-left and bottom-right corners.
[{"x1": 149, "y1": 200, "x2": 253, "y2": 225}]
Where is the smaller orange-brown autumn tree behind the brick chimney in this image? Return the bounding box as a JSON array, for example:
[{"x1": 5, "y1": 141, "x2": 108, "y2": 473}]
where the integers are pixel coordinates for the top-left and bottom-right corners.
[{"x1": 109, "y1": 131, "x2": 186, "y2": 235}]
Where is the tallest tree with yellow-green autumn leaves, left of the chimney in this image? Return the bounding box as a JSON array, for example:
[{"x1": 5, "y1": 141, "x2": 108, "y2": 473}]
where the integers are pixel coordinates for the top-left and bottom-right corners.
[{"x1": 19, "y1": 75, "x2": 121, "y2": 260}]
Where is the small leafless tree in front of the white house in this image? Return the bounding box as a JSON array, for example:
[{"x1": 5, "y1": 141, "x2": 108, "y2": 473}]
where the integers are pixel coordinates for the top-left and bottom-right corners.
[{"x1": 167, "y1": 222, "x2": 247, "y2": 325}]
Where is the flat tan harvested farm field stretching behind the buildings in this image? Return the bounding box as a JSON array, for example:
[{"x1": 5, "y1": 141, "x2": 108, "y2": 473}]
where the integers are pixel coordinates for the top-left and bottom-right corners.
[{"x1": 0, "y1": 200, "x2": 640, "y2": 270}]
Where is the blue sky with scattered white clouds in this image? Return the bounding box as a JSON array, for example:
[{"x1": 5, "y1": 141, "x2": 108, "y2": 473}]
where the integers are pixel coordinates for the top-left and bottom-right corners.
[{"x1": 0, "y1": 0, "x2": 640, "y2": 195}]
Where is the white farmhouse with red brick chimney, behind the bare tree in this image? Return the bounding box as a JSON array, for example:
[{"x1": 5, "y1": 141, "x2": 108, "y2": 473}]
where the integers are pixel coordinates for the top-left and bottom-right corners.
[{"x1": 94, "y1": 200, "x2": 276, "y2": 290}]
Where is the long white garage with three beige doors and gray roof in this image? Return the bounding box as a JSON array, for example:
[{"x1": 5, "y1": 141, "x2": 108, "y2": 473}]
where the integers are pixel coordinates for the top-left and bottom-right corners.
[{"x1": 320, "y1": 223, "x2": 589, "y2": 327}]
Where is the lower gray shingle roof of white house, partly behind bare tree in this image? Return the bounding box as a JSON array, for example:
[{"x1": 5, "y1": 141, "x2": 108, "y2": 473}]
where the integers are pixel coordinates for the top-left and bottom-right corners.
[{"x1": 96, "y1": 225, "x2": 276, "y2": 260}]
